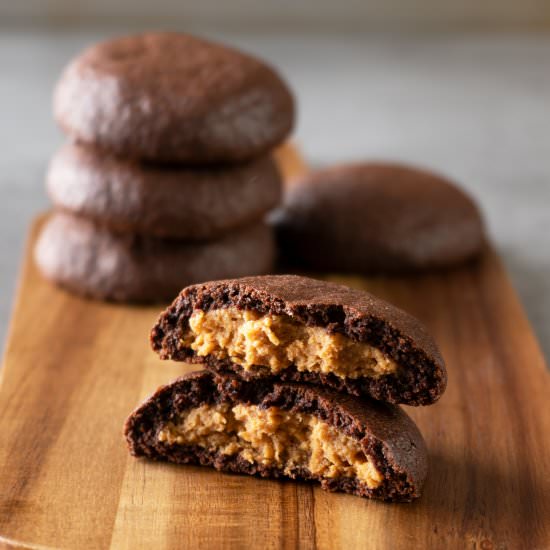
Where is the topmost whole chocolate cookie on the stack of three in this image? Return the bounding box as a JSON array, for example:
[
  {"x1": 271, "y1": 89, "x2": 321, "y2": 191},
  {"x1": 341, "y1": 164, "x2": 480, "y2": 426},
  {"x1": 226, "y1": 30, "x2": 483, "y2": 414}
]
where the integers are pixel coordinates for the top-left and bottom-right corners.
[{"x1": 54, "y1": 32, "x2": 294, "y2": 164}]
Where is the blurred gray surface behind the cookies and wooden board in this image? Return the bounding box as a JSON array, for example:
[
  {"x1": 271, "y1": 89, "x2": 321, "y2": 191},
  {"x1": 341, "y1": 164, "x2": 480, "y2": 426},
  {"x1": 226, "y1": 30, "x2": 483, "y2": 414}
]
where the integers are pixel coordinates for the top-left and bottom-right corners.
[{"x1": 0, "y1": 24, "x2": 550, "y2": 357}]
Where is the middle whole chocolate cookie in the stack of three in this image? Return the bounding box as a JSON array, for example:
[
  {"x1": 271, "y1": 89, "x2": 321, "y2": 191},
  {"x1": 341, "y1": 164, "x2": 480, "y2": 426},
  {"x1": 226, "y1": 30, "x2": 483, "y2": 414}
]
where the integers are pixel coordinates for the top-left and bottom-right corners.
[{"x1": 46, "y1": 144, "x2": 281, "y2": 240}]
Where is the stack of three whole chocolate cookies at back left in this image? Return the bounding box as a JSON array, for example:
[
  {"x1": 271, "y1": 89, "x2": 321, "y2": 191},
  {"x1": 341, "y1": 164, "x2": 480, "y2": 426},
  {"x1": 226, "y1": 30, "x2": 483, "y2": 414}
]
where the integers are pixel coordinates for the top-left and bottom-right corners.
[{"x1": 35, "y1": 33, "x2": 294, "y2": 302}]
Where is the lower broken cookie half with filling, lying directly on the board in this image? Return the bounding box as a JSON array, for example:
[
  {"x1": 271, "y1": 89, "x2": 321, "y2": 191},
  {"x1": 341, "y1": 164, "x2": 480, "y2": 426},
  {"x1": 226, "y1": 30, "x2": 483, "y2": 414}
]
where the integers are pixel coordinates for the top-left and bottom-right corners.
[{"x1": 124, "y1": 371, "x2": 427, "y2": 501}]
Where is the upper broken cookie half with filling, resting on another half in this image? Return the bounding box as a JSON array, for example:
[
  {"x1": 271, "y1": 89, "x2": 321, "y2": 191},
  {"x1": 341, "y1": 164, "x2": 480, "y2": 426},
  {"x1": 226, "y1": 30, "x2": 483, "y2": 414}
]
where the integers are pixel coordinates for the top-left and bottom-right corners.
[{"x1": 151, "y1": 275, "x2": 447, "y2": 405}]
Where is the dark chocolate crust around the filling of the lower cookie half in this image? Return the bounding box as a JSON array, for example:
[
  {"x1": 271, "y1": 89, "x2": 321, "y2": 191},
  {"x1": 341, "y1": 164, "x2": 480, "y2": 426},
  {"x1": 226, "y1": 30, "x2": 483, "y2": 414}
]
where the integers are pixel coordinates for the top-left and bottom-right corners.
[{"x1": 124, "y1": 371, "x2": 427, "y2": 501}]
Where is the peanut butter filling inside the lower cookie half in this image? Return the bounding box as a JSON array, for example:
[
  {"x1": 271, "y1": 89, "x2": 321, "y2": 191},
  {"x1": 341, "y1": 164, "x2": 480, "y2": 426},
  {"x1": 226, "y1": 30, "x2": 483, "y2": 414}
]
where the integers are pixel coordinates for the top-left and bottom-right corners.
[{"x1": 158, "y1": 403, "x2": 383, "y2": 489}]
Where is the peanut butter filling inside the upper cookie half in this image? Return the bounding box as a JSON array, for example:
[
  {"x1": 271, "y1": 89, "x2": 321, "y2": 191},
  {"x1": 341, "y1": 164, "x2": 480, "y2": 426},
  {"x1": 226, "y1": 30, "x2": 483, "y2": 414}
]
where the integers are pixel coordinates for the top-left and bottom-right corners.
[{"x1": 181, "y1": 308, "x2": 397, "y2": 378}]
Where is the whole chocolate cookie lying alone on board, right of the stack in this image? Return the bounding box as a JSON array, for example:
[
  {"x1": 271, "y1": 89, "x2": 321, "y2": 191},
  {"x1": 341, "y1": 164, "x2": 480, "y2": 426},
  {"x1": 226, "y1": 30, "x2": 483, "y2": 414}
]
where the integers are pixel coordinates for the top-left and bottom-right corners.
[{"x1": 272, "y1": 163, "x2": 485, "y2": 273}]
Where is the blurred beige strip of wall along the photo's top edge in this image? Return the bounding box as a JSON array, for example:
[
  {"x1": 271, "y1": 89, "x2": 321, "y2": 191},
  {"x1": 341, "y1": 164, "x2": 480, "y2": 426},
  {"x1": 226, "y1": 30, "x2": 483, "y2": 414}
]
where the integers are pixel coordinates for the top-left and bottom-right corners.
[{"x1": 0, "y1": 0, "x2": 550, "y2": 28}]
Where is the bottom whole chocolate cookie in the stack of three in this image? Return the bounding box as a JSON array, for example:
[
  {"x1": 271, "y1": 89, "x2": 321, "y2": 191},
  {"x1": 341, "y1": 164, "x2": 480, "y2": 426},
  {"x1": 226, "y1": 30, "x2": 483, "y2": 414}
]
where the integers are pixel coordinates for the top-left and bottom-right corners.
[{"x1": 35, "y1": 213, "x2": 274, "y2": 302}]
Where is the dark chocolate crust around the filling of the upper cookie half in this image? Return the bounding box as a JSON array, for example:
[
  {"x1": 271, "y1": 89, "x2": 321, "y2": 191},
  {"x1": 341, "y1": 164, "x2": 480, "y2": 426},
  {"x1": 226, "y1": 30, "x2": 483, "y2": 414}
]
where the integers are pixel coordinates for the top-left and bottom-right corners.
[{"x1": 151, "y1": 275, "x2": 447, "y2": 405}]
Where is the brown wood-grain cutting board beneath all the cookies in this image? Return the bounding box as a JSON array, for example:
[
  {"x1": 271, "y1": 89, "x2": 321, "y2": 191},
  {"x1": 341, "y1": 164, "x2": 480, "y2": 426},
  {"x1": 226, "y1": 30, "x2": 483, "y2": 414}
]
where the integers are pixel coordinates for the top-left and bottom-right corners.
[{"x1": 0, "y1": 149, "x2": 550, "y2": 550}]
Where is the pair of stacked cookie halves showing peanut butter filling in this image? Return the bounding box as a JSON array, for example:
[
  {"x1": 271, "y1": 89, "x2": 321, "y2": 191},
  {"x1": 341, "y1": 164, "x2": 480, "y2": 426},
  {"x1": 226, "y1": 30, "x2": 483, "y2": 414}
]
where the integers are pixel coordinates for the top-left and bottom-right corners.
[{"x1": 125, "y1": 275, "x2": 446, "y2": 501}]
